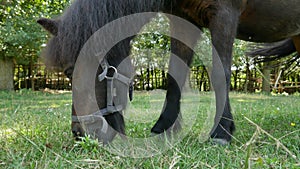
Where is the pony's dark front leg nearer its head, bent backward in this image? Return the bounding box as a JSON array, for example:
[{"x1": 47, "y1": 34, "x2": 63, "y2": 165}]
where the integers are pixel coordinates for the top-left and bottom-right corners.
[{"x1": 151, "y1": 18, "x2": 200, "y2": 134}]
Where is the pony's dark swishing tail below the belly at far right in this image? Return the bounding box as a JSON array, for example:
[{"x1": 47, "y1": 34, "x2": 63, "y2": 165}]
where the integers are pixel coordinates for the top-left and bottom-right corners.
[{"x1": 247, "y1": 39, "x2": 296, "y2": 62}]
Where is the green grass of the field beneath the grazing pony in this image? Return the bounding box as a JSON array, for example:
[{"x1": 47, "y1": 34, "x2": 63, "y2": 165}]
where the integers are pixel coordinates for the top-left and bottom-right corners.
[{"x1": 0, "y1": 90, "x2": 300, "y2": 169}]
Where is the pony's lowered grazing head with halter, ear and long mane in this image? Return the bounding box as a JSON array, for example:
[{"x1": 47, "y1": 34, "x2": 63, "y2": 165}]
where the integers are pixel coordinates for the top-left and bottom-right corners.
[{"x1": 38, "y1": 0, "x2": 169, "y2": 142}]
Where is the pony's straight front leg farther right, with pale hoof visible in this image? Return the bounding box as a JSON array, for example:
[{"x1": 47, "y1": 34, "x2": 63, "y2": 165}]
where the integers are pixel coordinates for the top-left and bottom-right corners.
[{"x1": 209, "y1": 2, "x2": 239, "y2": 144}]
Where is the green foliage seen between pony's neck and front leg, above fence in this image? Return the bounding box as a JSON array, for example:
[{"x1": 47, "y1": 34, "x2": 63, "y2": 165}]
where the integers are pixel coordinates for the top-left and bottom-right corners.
[{"x1": 131, "y1": 14, "x2": 171, "y2": 69}]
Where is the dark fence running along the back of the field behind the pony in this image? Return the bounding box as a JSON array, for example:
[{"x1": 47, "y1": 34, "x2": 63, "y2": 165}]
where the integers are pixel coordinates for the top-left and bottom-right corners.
[{"x1": 14, "y1": 64, "x2": 300, "y2": 93}]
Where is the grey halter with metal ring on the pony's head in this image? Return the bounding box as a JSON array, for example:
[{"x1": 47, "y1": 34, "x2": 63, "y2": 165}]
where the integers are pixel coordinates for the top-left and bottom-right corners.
[{"x1": 72, "y1": 58, "x2": 131, "y2": 123}]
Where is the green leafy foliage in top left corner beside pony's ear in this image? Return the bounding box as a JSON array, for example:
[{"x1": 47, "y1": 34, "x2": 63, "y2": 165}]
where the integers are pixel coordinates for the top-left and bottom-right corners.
[{"x1": 0, "y1": 0, "x2": 69, "y2": 64}]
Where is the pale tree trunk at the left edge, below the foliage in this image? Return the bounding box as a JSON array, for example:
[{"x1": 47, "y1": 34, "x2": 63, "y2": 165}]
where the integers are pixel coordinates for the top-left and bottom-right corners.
[{"x1": 0, "y1": 59, "x2": 14, "y2": 90}]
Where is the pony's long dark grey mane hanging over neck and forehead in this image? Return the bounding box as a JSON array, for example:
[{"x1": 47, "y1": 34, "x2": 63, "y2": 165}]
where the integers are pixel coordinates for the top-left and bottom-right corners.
[{"x1": 44, "y1": 0, "x2": 171, "y2": 70}]
